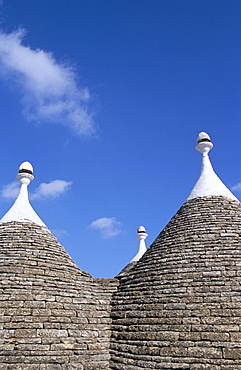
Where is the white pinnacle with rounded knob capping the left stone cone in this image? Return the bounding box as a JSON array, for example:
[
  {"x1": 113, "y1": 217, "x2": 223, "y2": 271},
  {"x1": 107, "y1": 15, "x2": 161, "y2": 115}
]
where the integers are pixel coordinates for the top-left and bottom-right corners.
[{"x1": 0, "y1": 162, "x2": 46, "y2": 227}]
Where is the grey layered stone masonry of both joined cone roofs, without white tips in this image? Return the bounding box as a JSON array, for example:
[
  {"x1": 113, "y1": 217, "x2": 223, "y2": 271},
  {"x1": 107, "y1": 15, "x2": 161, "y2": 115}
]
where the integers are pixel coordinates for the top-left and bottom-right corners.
[{"x1": 0, "y1": 197, "x2": 241, "y2": 370}]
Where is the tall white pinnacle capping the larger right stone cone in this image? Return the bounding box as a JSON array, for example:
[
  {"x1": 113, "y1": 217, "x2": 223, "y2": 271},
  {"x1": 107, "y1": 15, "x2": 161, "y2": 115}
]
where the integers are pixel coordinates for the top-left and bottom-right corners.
[{"x1": 187, "y1": 132, "x2": 238, "y2": 201}]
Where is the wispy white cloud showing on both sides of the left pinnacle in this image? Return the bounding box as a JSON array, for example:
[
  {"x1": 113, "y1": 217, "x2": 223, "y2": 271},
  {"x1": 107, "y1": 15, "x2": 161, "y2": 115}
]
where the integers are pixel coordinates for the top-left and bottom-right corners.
[{"x1": 1, "y1": 180, "x2": 72, "y2": 199}]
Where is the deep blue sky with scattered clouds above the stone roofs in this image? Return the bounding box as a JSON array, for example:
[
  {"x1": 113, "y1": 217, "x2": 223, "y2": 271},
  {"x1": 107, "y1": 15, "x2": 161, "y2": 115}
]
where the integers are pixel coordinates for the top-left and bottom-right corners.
[{"x1": 0, "y1": 0, "x2": 241, "y2": 277}]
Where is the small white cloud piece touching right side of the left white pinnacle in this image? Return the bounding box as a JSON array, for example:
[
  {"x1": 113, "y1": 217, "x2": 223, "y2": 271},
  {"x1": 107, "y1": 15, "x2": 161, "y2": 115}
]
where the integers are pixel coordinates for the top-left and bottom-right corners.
[{"x1": 30, "y1": 180, "x2": 72, "y2": 199}]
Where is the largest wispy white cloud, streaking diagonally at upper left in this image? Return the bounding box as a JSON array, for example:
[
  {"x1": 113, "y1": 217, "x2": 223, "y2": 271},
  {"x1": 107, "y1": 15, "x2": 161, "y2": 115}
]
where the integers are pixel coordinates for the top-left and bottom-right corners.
[{"x1": 0, "y1": 29, "x2": 95, "y2": 135}]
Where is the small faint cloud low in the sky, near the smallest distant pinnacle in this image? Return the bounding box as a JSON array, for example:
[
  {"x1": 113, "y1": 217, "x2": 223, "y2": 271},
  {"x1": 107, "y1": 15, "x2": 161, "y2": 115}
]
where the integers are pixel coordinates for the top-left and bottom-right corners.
[{"x1": 89, "y1": 217, "x2": 122, "y2": 239}]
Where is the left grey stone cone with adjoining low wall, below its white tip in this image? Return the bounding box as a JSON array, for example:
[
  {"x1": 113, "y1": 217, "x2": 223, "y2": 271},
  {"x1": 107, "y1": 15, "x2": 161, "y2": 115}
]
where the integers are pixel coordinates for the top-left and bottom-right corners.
[{"x1": 0, "y1": 222, "x2": 118, "y2": 370}]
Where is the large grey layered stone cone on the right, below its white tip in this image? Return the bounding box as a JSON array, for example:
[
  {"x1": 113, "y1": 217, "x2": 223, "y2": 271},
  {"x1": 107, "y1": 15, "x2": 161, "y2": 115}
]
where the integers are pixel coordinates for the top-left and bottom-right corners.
[{"x1": 110, "y1": 196, "x2": 241, "y2": 370}]
